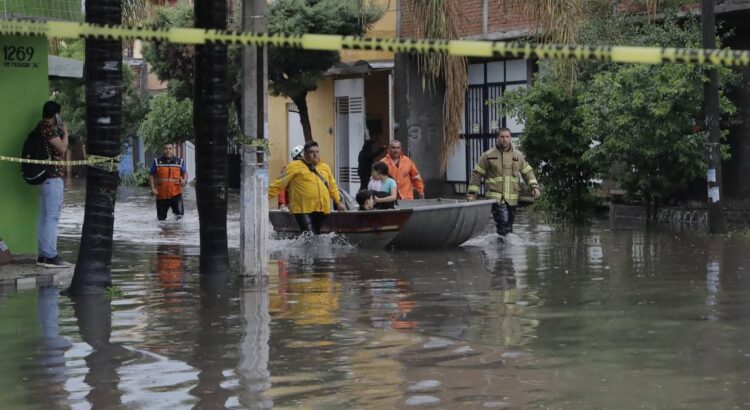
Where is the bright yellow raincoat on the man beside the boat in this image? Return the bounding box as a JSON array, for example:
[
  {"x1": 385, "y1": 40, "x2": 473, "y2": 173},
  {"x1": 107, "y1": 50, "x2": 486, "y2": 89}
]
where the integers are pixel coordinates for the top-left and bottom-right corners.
[{"x1": 268, "y1": 160, "x2": 341, "y2": 214}]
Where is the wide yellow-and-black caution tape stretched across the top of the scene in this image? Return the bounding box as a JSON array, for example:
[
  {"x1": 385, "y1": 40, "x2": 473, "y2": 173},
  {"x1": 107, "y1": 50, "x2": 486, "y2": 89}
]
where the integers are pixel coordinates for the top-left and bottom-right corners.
[{"x1": 0, "y1": 19, "x2": 750, "y2": 66}]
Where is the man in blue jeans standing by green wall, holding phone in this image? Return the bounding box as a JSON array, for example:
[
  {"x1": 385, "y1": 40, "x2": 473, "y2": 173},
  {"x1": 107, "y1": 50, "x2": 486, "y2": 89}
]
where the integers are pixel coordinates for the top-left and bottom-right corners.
[{"x1": 36, "y1": 101, "x2": 68, "y2": 268}]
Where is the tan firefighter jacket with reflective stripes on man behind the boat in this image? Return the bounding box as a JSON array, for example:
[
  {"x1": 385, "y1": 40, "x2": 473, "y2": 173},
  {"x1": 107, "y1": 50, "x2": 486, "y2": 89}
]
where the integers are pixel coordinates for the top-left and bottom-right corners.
[{"x1": 467, "y1": 145, "x2": 539, "y2": 206}]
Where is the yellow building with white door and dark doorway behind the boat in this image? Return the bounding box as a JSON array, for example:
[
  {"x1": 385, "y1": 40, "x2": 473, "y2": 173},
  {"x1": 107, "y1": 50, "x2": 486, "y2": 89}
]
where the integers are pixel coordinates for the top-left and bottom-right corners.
[{"x1": 268, "y1": 0, "x2": 397, "y2": 200}]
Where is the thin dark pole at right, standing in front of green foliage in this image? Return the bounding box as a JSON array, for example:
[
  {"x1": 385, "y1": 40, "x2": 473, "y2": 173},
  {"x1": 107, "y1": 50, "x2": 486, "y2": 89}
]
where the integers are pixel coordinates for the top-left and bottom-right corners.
[{"x1": 701, "y1": 0, "x2": 726, "y2": 234}]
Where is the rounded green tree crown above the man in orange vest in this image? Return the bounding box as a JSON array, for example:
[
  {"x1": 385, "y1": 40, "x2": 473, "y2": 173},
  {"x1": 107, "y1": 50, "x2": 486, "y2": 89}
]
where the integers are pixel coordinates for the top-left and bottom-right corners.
[{"x1": 140, "y1": 93, "x2": 193, "y2": 151}]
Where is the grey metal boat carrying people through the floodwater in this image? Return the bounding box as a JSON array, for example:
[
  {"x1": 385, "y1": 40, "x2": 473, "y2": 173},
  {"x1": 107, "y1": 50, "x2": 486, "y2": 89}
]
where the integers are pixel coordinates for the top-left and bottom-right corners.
[{"x1": 270, "y1": 199, "x2": 494, "y2": 249}]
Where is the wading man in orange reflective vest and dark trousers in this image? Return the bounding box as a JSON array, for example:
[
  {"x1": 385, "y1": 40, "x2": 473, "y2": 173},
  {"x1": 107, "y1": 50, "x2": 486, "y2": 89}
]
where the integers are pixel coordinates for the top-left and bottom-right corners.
[{"x1": 148, "y1": 143, "x2": 188, "y2": 221}]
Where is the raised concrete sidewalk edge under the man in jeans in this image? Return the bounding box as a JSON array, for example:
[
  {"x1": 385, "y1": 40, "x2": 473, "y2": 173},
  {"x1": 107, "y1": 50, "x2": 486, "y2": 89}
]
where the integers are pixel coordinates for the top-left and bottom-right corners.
[{"x1": 0, "y1": 255, "x2": 75, "y2": 290}]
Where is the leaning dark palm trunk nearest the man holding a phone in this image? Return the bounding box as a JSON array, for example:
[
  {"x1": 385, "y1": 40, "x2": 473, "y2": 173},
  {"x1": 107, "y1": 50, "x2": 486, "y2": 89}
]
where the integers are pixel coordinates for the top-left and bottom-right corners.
[{"x1": 68, "y1": 0, "x2": 122, "y2": 295}]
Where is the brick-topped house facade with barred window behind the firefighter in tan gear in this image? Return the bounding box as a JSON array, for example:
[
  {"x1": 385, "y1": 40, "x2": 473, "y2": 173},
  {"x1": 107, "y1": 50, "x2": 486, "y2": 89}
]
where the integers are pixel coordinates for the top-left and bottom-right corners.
[{"x1": 394, "y1": 0, "x2": 750, "y2": 199}]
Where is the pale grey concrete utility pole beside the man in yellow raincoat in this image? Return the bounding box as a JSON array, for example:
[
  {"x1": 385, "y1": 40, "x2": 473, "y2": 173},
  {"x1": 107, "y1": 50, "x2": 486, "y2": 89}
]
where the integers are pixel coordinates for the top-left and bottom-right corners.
[{"x1": 240, "y1": 0, "x2": 269, "y2": 283}]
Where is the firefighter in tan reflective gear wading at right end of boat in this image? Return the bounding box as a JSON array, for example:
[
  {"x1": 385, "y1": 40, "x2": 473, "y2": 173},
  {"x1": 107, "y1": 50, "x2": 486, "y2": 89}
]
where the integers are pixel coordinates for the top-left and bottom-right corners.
[{"x1": 466, "y1": 128, "x2": 540, "y2": 236}]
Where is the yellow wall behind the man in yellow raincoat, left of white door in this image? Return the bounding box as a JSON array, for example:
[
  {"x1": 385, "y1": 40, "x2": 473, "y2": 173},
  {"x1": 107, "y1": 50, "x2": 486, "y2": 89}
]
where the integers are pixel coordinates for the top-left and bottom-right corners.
[{"x1": 268, "y1": 78, "x2": 336, "y2": 208}]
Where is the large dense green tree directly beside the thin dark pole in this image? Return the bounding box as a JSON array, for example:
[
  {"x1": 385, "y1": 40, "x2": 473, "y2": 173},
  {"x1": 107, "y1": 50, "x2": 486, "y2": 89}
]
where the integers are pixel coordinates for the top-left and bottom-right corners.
[{"x1": 579, "y1": 18, "x2": 736, "y2": 208}]
